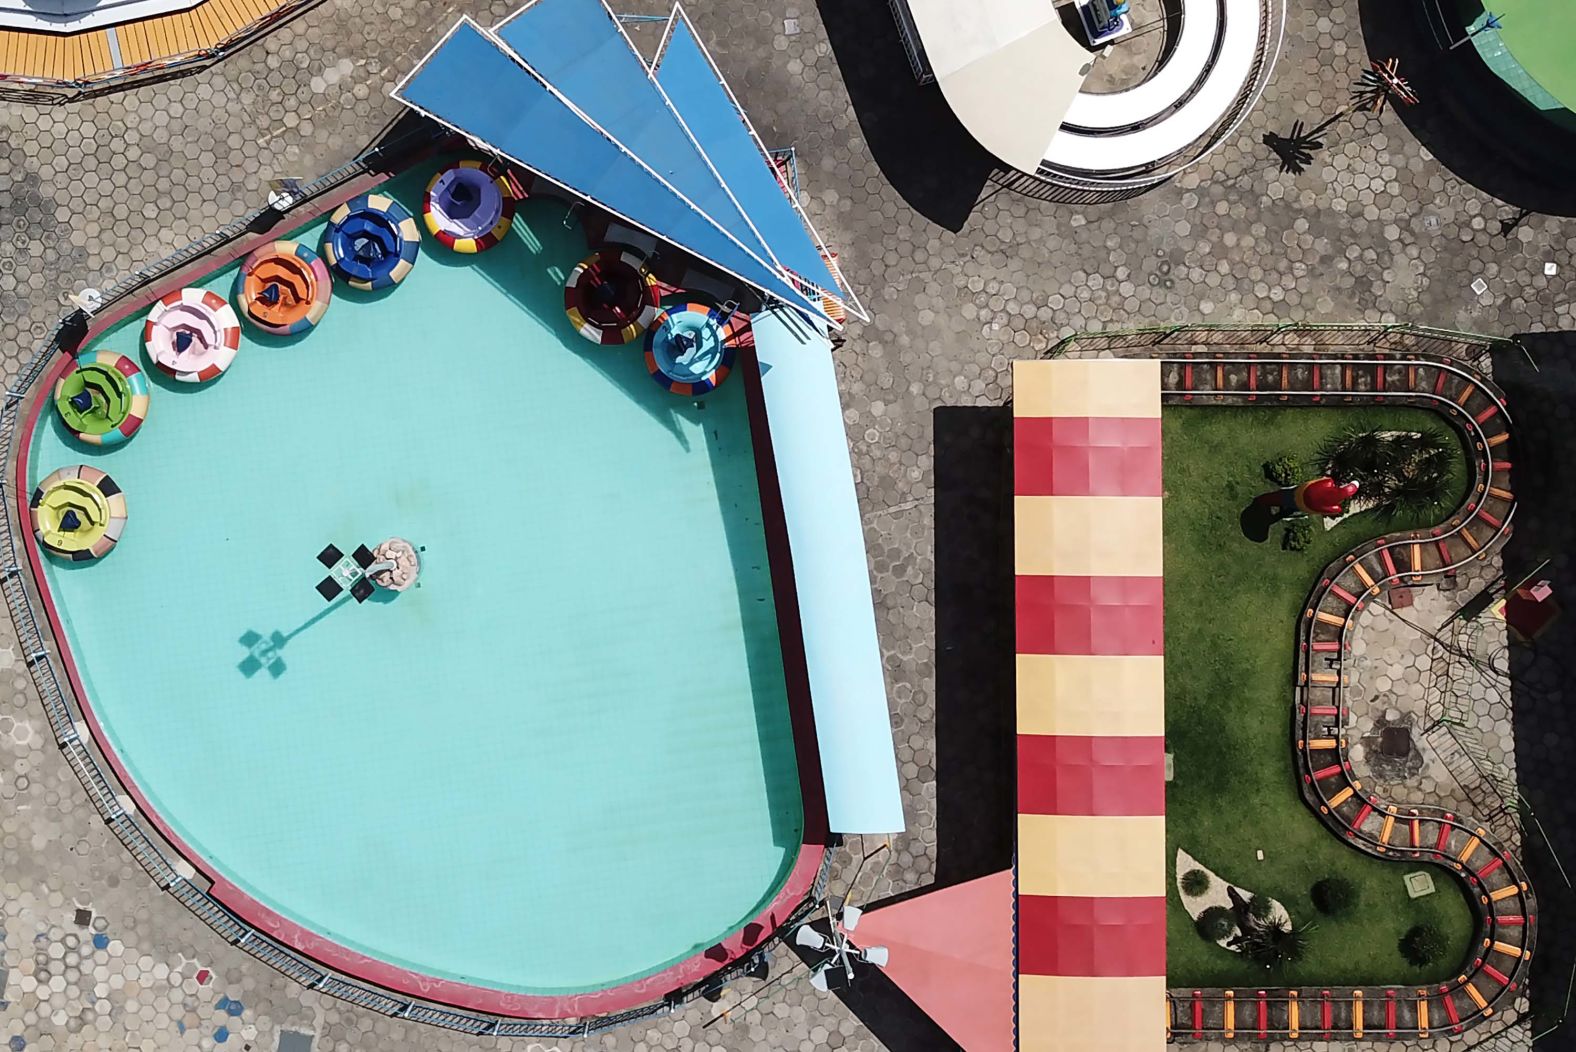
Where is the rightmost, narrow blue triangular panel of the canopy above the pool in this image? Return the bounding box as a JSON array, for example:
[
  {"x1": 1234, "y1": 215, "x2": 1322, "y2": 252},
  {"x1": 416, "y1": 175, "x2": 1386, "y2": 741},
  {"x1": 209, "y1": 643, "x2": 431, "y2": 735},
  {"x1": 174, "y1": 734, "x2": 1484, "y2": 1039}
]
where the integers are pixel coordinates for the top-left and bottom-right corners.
[{"x1": 656, "y1": 9, "x2": 851, "y2": 299}]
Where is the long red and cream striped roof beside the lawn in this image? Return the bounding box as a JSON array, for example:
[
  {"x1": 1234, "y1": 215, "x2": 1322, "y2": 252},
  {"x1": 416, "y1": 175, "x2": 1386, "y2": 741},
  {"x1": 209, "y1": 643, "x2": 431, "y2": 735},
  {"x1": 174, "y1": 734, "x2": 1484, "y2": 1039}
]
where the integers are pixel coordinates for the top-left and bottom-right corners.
[{"x1": 1013, "y1": 361, "x2": 1166, "y2": 1052}]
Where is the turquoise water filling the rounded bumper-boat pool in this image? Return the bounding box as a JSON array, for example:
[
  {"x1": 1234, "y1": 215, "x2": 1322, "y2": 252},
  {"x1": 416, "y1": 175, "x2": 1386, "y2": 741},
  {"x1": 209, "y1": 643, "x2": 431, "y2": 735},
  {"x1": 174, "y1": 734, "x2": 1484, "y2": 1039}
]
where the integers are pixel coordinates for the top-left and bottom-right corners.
[{"x1": 30, "y1": 169, "x2": 802, "y2": 994}]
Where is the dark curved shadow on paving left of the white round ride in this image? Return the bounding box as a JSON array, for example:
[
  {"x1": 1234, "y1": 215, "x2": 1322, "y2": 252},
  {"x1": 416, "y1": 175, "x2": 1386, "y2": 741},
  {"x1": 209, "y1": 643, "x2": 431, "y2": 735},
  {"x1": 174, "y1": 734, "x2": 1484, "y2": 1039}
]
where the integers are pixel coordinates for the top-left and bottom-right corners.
[{"x1": 818, "y1": 0, "x2": 989, "y2": 232}]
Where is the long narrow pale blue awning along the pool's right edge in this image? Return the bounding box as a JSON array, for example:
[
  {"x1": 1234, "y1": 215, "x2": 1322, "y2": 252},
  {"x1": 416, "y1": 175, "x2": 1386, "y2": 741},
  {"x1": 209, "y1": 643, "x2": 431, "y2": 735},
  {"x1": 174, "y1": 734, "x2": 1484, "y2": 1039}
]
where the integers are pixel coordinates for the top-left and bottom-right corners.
[{"x1": 752, "y1": 309, "x2": 903, "y2": 833}]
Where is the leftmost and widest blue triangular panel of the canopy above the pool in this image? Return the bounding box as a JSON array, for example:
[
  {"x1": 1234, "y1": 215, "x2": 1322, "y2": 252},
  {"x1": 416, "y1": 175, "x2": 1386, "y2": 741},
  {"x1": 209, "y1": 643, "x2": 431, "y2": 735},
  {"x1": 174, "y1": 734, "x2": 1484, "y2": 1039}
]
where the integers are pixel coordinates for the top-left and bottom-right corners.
[{"x1": 394, "y1": 19, "x2": 823, "y2": 317}]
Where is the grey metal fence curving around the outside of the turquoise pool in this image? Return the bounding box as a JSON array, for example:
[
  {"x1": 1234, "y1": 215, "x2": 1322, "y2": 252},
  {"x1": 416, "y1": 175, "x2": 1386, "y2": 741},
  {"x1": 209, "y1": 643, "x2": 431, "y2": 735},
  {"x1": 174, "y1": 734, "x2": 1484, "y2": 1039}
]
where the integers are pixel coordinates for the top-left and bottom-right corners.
[{"x1": 0, "y1": 123, "x2": 840, "y2": 1039}]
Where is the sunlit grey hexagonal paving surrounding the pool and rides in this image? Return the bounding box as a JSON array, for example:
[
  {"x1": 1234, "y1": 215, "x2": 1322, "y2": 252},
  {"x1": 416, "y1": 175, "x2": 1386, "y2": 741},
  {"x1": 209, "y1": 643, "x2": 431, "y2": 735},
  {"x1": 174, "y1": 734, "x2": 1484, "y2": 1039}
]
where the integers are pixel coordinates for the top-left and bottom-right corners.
[{"x1": 0, "y1": 0, "x2": 1576, "y2": 1052}]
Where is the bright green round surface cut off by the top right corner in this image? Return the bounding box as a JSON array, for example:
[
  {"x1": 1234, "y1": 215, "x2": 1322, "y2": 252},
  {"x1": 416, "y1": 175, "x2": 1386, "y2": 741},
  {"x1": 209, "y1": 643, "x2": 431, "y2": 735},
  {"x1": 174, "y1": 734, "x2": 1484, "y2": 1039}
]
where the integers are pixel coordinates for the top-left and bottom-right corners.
[{"x1": 1461, "y1": 0, "x2": 1576, "y2": 110}]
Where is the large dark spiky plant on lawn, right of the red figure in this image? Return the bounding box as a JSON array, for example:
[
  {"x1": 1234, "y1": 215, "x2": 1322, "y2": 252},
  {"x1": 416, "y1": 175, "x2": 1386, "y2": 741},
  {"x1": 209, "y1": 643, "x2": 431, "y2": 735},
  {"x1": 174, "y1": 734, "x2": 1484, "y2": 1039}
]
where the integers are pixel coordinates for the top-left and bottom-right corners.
[{"x1": 1319, "y1": 428, "x2": 1456, "y2": 520}]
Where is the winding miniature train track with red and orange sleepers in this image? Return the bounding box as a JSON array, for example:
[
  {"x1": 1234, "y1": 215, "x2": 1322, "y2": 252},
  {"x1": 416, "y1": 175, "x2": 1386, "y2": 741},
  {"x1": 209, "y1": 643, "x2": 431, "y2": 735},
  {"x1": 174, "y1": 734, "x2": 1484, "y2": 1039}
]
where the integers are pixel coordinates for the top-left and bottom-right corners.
[{"x1": 1155, "y1": 351, "x2": 1537, "y2": 1041}]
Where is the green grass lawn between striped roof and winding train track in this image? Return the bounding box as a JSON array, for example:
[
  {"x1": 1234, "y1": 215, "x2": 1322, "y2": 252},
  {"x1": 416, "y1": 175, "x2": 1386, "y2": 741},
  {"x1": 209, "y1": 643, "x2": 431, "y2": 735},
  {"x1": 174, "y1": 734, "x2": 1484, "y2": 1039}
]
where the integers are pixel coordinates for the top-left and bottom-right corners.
[{"x1": 1165, "y1": 406, "x2": 1472, "y2": 986}]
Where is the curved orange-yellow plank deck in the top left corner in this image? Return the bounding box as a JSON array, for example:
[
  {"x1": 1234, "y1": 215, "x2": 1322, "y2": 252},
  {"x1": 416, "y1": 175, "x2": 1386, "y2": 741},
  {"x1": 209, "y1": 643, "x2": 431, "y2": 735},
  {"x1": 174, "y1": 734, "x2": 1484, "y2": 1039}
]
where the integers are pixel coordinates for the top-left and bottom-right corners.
[{"x1": 0, "y1": 0, "x2": 287, "y2": 80}]
